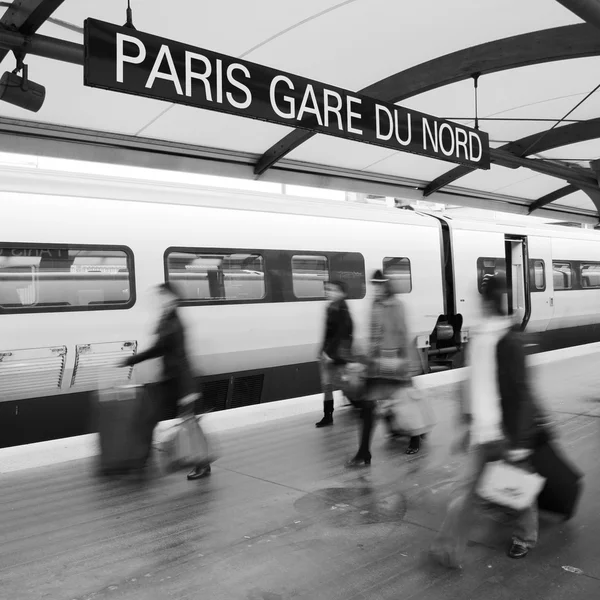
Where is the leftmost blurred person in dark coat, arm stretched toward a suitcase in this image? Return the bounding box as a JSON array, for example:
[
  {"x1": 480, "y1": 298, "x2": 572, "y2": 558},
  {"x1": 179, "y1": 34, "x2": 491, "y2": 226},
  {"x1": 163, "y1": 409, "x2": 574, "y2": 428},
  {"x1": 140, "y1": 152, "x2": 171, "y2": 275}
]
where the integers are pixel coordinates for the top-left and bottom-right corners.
[{"x1": 123, "y1": 282, "x2": 211, "y2": 480}]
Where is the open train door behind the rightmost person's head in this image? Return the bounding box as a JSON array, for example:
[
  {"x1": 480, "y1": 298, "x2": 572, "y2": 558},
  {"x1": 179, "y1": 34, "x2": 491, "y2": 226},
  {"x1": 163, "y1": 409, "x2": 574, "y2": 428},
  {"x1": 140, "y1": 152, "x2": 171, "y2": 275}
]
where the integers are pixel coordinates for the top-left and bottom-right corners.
[{"x1": 504, "y1": 235, "x2": 531, "y2": 330}]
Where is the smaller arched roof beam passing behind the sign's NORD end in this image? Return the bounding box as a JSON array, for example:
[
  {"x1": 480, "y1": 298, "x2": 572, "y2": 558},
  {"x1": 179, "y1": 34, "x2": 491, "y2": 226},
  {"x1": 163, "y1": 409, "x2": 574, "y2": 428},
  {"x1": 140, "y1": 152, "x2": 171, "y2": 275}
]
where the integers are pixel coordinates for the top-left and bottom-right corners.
[{"x1": 423, "y1": 115, "x2": 600, "y2": 196}]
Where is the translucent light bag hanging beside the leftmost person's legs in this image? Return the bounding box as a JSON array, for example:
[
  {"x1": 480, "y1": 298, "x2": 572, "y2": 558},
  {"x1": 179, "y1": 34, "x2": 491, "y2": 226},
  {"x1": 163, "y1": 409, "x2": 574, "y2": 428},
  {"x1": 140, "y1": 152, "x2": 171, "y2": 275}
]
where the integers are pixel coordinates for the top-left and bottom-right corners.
[{"x1": 157, "y1": 416, "x2": 216, "y2": 471}]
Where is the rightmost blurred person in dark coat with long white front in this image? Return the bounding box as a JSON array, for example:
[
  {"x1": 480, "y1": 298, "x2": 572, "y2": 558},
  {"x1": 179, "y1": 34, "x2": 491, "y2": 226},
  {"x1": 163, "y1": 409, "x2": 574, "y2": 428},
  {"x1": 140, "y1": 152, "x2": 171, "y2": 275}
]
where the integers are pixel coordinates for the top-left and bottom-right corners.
[{"x1": 431, "y1": 276, "x2": 544, "y2": 567}]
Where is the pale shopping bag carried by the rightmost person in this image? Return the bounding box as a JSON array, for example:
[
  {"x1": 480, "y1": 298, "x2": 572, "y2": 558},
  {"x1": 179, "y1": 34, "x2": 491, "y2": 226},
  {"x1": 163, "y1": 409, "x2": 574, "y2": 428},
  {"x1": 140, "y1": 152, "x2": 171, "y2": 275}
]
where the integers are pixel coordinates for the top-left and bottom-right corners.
[{"x1": 477, "y1": 461, "x2": 546, "y2": 510}]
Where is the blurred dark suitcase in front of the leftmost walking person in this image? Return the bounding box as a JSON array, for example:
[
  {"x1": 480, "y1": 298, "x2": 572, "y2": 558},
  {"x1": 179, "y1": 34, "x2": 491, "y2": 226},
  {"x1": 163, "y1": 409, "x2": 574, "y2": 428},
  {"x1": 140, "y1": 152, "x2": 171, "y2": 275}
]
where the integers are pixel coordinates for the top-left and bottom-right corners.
[{"x1": 96, "y1": 385, "x2": 155, "y2": 475}]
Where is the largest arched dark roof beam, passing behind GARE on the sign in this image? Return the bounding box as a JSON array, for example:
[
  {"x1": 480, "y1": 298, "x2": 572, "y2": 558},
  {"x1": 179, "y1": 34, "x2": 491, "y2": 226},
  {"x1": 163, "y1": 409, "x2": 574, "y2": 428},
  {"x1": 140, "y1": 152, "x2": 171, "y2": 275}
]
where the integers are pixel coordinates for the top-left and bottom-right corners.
[{"x1": 254, "y1": 23, "x2": 600, "y2": 175}]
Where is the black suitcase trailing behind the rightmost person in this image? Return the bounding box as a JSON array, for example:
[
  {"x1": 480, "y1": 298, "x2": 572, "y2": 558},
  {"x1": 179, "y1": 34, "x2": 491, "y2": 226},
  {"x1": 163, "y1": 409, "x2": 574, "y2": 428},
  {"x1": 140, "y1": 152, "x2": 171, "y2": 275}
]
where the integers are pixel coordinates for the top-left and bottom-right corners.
[{"x1": 532, "y1": 442, "x2": 582, "y2": 520}]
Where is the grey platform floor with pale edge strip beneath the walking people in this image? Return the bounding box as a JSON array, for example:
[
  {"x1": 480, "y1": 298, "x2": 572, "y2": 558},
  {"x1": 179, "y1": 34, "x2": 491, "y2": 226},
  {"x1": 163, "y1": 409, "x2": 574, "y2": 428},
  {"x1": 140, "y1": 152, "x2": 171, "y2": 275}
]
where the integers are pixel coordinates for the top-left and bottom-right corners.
[{"x1": 0, "y1": 355, "x2": 600, "y2": 600}]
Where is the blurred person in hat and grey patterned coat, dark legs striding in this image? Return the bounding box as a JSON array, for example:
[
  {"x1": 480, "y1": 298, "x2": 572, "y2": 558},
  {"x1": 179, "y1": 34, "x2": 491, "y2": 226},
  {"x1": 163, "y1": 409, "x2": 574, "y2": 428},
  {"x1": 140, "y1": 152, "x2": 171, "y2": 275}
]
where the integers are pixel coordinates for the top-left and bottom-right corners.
[{"x1": 347, "y1": 269, "x2": 421, "y2": 467}]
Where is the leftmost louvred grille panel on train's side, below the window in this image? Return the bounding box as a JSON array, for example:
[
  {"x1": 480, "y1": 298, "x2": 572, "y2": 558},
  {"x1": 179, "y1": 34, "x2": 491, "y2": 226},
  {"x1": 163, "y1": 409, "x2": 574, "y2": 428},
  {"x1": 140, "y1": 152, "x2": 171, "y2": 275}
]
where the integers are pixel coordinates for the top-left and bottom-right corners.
[{"x1": 0, "y1": 346, "x2": 67, "y2": 402}]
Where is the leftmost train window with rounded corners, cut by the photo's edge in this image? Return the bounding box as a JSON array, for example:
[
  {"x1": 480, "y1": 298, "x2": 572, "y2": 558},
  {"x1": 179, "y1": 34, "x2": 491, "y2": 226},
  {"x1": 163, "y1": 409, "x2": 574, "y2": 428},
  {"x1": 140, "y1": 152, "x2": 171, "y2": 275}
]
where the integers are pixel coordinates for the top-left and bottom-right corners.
[{"x1": 0, "y1": 244, "x2": 134, "y2": 312}]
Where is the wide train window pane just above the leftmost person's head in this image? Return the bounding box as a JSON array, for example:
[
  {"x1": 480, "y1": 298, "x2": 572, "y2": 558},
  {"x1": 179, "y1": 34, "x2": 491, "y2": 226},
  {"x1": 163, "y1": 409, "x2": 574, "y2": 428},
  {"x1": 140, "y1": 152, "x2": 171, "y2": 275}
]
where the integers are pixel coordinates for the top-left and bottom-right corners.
[{"x1": 167, "y1": 250, "x2": 265, "y2": 302}]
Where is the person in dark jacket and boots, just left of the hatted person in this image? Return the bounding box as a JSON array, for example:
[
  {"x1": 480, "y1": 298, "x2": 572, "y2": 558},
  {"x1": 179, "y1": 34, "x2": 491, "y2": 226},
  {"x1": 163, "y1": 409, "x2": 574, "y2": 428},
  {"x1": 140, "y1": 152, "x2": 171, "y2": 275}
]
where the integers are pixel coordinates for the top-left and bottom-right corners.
[{"x1": 316, "y1": 281, "x2": 353, "y2": 427}]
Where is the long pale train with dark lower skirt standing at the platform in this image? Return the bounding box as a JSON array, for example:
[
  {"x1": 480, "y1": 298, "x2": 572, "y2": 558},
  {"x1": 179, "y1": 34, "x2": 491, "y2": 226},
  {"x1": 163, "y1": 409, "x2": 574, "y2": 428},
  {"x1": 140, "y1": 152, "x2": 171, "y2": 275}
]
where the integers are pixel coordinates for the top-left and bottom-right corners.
[{"x1": 0, "y1": 168, "x2": 600, "y2": 447}]
